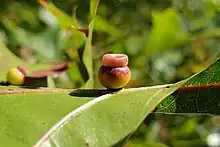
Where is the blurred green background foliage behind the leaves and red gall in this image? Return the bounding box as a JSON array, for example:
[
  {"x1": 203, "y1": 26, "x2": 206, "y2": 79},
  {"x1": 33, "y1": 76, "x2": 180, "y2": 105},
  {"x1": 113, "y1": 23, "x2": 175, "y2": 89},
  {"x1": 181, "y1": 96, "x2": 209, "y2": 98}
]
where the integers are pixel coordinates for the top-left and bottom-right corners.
[{"x1": 0, "y1": 0, "x2": 220, "y2": 147}]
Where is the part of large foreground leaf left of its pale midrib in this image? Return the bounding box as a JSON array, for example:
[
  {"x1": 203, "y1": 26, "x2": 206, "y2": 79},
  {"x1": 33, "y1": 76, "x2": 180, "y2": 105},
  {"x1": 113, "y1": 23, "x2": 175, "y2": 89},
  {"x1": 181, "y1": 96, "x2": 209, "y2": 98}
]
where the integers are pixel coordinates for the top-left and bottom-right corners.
[{"x1": 0, "y1": 86, "x2": 90, "y2": 147}]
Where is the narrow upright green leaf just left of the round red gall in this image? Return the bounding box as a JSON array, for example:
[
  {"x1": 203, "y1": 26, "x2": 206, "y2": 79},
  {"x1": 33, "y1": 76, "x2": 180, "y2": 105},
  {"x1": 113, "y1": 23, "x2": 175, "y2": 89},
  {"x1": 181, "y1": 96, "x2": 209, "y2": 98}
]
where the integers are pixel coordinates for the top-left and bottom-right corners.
[{"x1": 83, "y1": 0, "x2": 99, "y2": 88}]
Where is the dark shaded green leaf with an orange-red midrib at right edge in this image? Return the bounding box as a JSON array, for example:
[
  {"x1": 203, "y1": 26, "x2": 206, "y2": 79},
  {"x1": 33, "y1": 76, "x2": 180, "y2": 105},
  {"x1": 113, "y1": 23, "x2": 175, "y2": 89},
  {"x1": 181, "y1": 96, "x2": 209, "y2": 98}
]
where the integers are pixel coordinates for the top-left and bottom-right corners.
[{"x1": 157, "y1": 58, "x2": 220, "y2": 115}]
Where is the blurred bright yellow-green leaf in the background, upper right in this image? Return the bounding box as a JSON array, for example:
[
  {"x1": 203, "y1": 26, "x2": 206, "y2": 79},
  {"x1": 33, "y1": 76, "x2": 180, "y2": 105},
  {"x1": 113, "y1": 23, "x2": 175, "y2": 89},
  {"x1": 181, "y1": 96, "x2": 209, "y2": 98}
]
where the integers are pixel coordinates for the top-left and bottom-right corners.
[{"x1": 145, "y1": 8, "x2": 188, "y2": 54}]
